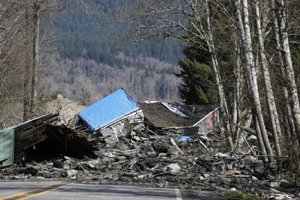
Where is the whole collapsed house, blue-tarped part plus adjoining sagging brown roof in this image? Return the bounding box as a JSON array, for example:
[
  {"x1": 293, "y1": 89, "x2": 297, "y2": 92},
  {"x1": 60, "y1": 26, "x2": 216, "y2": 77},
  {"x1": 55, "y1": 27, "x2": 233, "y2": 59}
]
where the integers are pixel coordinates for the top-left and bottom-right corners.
[{"x1": 77, "y1": 88, "x2": 220, "y2": 143}]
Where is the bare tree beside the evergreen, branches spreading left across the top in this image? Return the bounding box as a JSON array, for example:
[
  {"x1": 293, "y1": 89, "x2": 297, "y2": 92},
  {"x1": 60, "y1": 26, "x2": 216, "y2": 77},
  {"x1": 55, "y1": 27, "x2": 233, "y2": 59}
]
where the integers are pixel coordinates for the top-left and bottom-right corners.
[{"x1": 122, "y1": 0, "x2": 233, "y2": 148}]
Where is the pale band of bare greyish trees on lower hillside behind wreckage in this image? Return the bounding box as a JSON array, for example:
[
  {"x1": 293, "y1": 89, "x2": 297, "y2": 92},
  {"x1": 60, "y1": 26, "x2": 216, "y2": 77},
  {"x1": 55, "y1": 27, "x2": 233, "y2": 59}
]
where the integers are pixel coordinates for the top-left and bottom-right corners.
[{"x1": 40, "y1": 53, "x2": 180, "y2": 105}]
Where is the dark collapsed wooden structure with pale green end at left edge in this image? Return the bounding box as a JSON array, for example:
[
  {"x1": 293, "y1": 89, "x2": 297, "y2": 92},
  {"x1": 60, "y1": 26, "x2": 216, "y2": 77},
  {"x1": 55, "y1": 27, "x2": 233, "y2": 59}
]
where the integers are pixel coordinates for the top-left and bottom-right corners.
[{"x1": 0, "y1": 114, "x2": 96, "y2": 168}]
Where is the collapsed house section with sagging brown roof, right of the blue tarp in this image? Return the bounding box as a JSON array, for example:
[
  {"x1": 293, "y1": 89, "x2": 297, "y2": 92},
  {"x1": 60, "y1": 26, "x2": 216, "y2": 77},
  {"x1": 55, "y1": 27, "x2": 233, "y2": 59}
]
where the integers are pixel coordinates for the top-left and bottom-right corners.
[{"x1": 140, "y1": 102, "x2": 220, "y2": 134}]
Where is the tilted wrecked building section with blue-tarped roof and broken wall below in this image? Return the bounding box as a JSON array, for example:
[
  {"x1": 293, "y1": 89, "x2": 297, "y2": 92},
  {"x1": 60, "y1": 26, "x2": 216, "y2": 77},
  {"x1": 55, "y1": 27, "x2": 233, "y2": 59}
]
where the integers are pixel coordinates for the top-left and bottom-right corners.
[{"x1": 77, "y1": 88, "x2": 143, "y2": 143}]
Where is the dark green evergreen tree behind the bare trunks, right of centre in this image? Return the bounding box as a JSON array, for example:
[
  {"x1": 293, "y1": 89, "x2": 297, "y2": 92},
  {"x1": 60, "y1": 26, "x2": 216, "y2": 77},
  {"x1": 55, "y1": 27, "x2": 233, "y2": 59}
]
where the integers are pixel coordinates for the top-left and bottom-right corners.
[{"x1": 175, "y1": 45, "x2": 218, "y2": 105}]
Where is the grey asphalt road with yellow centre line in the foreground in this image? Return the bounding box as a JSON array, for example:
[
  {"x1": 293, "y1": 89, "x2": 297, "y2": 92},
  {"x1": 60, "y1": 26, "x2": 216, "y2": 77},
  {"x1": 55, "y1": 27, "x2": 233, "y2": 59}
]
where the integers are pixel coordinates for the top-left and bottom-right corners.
[{"x1": 0, "y1": 181, "x2": 220, "y2": 200}]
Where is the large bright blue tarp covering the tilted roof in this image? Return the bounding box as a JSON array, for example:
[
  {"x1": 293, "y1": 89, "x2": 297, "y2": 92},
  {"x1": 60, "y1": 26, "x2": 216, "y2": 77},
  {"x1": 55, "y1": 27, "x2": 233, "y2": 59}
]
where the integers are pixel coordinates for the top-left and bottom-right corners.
[{"x1": 78, "y1": 88, "x2": 141, "y2": 131}]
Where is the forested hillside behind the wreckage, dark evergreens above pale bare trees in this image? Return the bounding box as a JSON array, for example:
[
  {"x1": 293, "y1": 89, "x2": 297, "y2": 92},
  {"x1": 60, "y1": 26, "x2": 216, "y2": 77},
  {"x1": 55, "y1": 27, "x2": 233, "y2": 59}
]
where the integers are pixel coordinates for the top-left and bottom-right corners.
[{"x1": 40, "y1": 0, "x2": 182, "y2": 105}]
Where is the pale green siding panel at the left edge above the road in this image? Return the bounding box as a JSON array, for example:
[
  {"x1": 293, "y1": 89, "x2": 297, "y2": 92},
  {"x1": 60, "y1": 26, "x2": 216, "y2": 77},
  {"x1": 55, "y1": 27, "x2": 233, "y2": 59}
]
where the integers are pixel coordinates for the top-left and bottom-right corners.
[{"x1": 0, "y1": 128, "x2": 15, "y2": 166}]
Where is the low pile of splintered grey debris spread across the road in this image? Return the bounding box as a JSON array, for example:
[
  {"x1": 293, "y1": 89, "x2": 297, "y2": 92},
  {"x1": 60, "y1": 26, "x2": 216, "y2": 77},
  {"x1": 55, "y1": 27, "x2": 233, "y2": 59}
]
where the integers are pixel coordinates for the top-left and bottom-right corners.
[{"x1": 0, "y1": 126, "x2": 299, "y2": 196}]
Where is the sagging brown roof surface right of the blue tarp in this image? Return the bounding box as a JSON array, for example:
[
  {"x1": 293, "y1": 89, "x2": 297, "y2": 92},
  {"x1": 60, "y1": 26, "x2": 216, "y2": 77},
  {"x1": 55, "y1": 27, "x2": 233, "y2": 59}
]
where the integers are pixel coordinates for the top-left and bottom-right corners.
[{"x1": 140, "y1": 102, "x2": 214, "y2": 128}]
